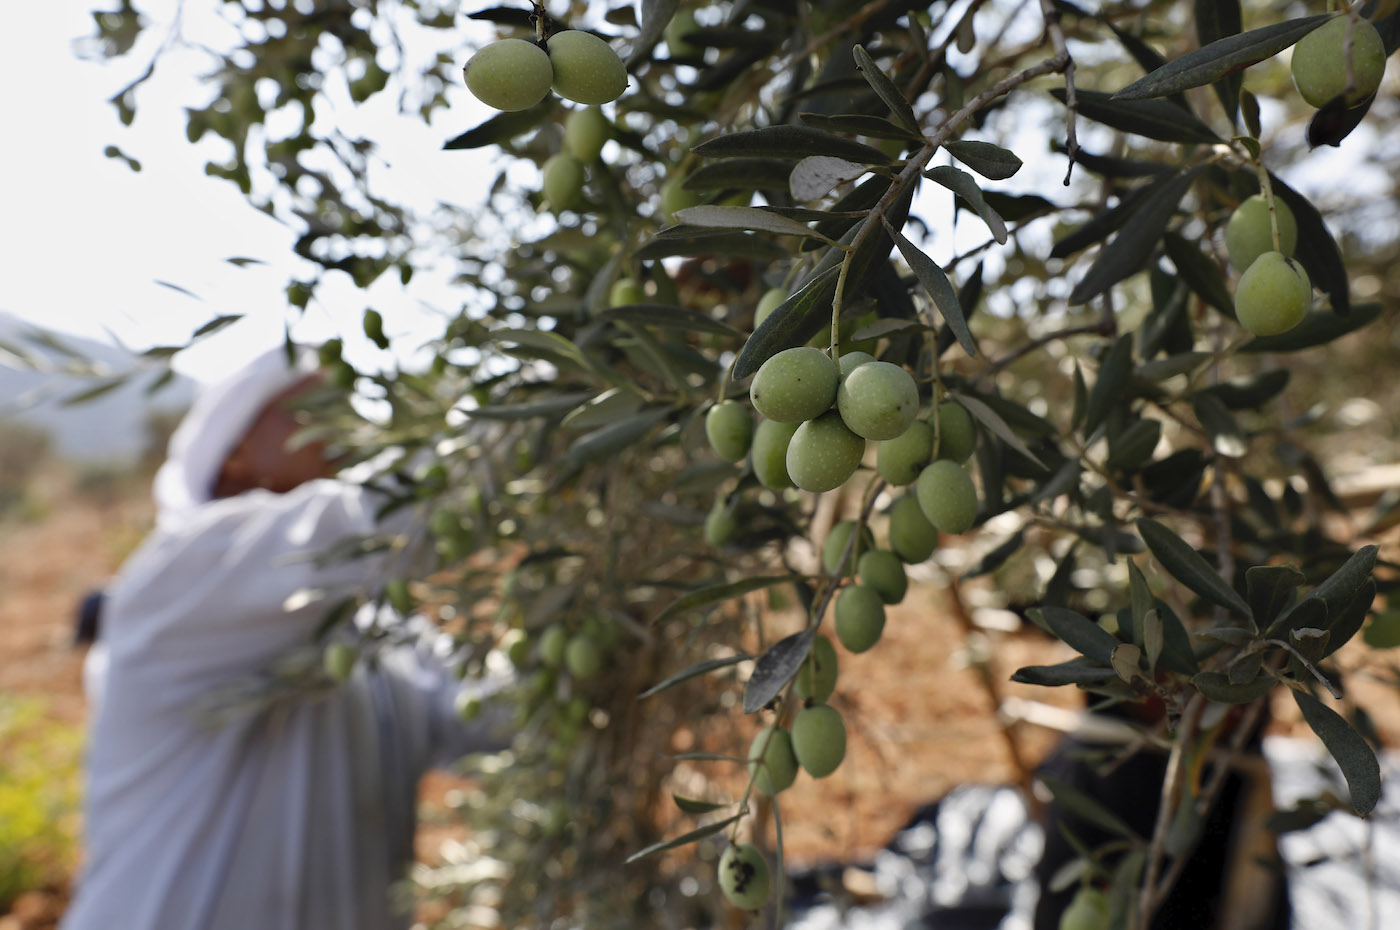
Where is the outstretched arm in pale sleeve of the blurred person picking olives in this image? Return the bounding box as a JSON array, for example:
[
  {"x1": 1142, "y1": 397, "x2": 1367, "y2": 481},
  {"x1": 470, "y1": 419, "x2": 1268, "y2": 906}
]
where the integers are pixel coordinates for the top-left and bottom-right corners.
[{"x1": 104, "y1": 479, "x2": 417, "y2": 700}]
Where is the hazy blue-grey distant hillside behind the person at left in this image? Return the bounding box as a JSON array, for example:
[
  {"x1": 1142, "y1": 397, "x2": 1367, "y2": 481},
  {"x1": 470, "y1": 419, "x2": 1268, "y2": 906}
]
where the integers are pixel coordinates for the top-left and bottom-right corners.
[{"x1": 0, "y1": 312, "x2": 193, "y2": 462}]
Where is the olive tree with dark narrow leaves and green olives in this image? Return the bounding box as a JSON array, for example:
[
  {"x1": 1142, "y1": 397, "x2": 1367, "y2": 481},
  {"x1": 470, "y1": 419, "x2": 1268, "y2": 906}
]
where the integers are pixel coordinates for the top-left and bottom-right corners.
[{"x1": 84, "y1": 0, "x2": 1400, "y2": 927}]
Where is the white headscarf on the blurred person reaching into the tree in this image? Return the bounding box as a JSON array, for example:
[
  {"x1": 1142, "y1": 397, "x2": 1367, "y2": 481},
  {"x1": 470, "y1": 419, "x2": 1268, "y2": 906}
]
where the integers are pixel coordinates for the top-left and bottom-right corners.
[{"x1": 155, "y1": 346, "x2": 316, "y2": 529}]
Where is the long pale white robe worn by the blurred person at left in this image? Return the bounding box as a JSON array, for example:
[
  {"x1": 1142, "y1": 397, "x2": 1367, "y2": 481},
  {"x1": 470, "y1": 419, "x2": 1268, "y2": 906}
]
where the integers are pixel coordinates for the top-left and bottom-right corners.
[{"x1": 62, "y1": 479, "x2": 504, "y2": 930}]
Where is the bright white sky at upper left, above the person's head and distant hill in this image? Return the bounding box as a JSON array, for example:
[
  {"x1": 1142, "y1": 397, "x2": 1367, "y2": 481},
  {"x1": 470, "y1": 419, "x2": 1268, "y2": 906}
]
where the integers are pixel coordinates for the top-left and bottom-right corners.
[{"x1": 0, "y1": 0, "x2": 494, "y2": 378}]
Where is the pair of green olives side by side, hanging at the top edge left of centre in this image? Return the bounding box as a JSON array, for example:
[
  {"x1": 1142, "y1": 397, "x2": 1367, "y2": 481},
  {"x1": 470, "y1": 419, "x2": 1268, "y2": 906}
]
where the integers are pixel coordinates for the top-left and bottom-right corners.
[{"x1": 465, "y1": 29, "x2": 627, "y2": 111}]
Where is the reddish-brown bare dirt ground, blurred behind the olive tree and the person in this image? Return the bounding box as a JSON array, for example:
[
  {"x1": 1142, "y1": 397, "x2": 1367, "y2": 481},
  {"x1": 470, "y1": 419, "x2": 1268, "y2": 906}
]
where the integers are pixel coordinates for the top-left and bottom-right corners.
[{"x1": 0, "y1": 475, "x2": 1400, "y2": 930}]
